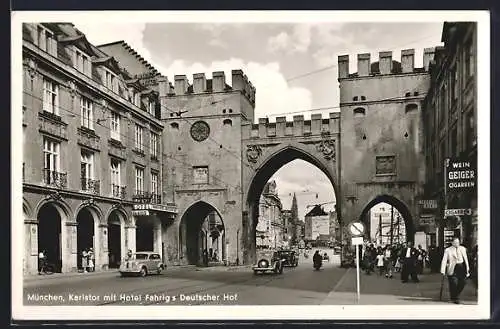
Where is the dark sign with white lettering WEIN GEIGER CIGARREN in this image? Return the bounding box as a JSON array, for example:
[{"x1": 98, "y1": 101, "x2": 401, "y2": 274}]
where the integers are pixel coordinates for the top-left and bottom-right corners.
[{"x1": 445, "y1": 159, "x2": 477, "y2": 193}]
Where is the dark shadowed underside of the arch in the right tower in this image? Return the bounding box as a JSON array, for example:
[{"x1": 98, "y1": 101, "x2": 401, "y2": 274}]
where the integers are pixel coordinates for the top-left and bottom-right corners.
[{"x1": 359, "y1": 194, "x2": 415, "y2": 242}]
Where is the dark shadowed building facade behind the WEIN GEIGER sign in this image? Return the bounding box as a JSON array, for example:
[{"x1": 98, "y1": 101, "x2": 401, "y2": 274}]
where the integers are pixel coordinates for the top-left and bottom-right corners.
[{"x1": 423, "y1": 22, "x2": 477, "y2": 248}]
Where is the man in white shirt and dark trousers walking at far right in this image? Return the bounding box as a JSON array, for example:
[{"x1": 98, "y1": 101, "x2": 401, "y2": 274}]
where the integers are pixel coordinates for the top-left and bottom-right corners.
[{"x1": 441, "y1": 237, "x2": 470, "y2": 304}]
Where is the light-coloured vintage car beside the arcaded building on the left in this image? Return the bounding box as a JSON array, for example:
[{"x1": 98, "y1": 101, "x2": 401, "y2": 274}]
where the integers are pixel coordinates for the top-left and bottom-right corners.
[{"x1": 119, "y1": 251, "x2": 165, "y2": 277}]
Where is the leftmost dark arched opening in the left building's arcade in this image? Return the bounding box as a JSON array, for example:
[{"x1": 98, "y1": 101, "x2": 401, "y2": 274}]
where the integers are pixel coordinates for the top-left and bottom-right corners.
[{"x1": 37, "y1": 203, "x2": 62, "y2": 273}]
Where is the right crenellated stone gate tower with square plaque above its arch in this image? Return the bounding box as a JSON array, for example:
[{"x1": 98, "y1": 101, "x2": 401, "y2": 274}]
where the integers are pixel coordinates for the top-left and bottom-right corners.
[{"x1": 338, "y1": 48, "x2": 434, "y2": 240}]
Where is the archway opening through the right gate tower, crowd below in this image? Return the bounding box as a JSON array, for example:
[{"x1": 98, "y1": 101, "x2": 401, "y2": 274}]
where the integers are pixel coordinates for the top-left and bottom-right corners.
[{"x1": 359, "y1": 195, "x2": 415, "y2": 243}]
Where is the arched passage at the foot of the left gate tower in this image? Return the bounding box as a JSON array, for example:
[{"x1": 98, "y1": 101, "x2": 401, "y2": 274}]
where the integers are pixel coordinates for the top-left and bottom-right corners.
[{"x1": 179, "y1": 201, "x2": 226, "y2": 265}]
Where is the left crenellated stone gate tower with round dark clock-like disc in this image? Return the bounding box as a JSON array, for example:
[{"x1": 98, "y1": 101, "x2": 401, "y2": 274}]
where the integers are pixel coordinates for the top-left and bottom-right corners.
[{"x1": 159, "y1": 70, "x2": 255, "y2": 264}]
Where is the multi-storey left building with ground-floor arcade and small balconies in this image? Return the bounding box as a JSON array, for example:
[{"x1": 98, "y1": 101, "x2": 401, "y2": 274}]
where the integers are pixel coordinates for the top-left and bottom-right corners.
[{"x1": 22, "y1": 23, "x2": 176, "y2": 273}]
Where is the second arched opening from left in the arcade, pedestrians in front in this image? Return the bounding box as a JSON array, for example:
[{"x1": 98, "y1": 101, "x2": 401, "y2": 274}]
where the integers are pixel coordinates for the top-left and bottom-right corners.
[{"x1": 76, "y1": 207, "x2": 97, "y2": 269}]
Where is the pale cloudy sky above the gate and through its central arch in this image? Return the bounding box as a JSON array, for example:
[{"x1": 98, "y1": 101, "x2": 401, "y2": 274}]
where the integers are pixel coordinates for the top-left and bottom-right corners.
[{"x1": 73, "y1": 20, "x2": 443, "y2": 222}]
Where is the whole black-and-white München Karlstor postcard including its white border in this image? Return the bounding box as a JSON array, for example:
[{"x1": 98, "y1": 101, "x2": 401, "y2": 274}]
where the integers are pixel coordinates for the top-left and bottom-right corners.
[{"x1": 11, "y1": 11, "x2": 491, "y2": 320}]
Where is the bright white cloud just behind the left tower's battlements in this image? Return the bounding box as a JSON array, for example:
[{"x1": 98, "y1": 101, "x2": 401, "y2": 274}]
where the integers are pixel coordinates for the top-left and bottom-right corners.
[{"x1": 165, "y1": 58, "x2": 312, "y2": 118}]
